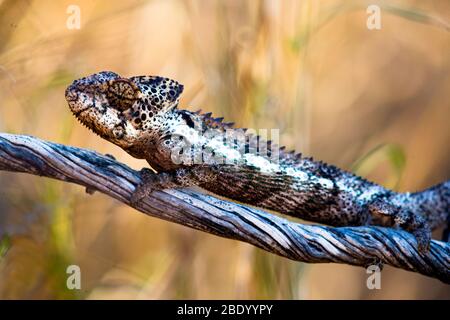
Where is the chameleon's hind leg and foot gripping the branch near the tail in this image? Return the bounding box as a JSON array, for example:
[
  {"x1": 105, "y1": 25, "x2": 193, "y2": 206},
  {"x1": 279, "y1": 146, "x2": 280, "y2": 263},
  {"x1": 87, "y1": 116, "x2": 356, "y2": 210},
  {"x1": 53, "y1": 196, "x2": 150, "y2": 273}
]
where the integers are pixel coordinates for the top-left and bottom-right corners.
[{"x1": 369, "y1": 199, "x2": 431, "y2": 253}]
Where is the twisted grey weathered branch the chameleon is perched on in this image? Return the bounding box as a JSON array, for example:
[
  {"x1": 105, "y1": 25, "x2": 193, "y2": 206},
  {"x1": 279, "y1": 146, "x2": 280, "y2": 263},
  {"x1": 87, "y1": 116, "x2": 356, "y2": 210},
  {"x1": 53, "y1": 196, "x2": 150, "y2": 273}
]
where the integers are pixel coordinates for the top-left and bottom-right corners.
[{"x1": 0, "y1": 133, "x2": 450, "y2": 283}]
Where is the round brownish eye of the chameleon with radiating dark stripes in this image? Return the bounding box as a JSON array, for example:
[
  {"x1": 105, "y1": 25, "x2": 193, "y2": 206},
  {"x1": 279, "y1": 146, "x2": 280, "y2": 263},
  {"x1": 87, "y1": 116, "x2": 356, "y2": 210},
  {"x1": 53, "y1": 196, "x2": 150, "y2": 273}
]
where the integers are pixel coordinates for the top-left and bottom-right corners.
[{"x1": 106, "y1": 78, "x2": 139, "y2": 111}]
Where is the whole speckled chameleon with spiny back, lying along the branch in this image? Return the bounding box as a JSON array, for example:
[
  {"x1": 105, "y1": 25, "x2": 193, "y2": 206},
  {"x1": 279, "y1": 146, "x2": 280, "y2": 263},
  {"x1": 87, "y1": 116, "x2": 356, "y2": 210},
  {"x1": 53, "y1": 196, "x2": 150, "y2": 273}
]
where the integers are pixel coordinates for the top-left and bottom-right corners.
[{"x1": 66, "y1": 71, "x2": 450, "y2": 251}]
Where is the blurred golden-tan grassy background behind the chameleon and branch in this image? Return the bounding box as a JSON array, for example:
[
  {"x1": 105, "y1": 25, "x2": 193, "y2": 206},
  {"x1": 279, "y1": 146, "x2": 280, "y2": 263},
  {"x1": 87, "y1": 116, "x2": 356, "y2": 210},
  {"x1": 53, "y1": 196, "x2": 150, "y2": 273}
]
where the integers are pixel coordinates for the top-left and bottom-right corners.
[{"x1": 0, "y1": 0, "x2": 450, "y2": 299}]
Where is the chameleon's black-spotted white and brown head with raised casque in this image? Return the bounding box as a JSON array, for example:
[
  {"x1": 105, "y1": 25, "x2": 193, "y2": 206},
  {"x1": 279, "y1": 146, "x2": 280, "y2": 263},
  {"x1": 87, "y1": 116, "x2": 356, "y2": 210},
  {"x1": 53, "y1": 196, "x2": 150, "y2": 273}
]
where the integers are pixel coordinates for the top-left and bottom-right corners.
[{"x1": 66, "y1": 71, "x2": 183, "y2": 149}]
